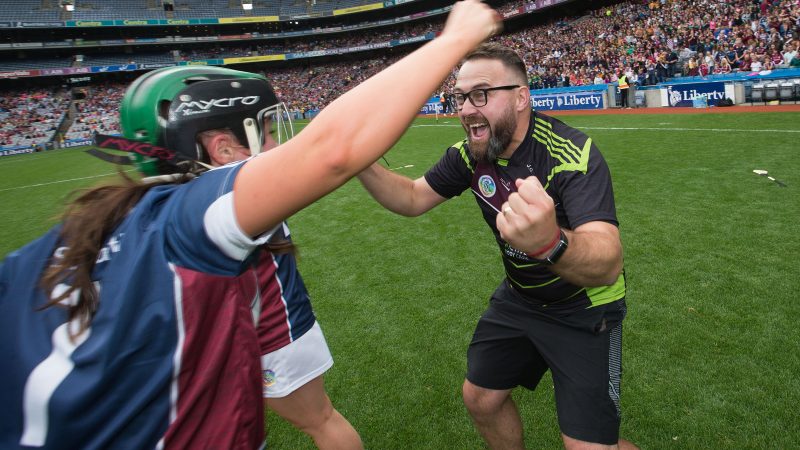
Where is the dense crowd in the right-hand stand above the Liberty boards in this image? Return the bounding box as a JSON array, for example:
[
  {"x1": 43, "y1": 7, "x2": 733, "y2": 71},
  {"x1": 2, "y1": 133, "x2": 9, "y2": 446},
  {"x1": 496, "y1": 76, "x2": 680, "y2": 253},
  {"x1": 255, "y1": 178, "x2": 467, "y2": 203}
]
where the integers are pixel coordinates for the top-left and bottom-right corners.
[{"x1": 499, "y1": 0, "x2": 800, "y2": 88}]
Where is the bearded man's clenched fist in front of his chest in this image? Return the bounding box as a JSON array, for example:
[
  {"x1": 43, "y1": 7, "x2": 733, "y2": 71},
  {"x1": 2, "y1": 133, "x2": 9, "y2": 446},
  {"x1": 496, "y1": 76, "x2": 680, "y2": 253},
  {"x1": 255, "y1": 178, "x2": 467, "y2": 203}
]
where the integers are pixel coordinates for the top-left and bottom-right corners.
[{"x1": 497, "y1": 176, "x2": 561, "y2": 257}]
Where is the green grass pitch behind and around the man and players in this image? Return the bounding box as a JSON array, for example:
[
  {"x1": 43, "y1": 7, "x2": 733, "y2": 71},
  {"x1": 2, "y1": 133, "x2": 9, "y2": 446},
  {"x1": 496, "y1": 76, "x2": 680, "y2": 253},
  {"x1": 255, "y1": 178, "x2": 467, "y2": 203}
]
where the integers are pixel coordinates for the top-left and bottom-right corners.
[{"x1": 0, "y1": 113, "x2": 800, "y2": 449}]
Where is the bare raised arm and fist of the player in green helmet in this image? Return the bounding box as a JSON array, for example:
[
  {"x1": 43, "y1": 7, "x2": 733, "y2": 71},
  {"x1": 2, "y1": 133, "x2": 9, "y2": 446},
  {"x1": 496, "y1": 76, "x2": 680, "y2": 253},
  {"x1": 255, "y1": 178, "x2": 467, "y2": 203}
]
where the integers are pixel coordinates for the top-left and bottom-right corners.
[{"x1": 234, "y1": 0, "x2": 499, "y2": 236}]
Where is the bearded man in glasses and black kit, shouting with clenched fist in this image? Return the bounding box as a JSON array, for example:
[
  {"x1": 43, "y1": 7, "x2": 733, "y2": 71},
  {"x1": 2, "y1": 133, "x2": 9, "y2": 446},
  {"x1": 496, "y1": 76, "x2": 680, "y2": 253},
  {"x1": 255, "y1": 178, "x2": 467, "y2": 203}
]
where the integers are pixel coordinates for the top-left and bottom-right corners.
[{"x1": 359, "y1": 44, "x2": 631, "y2": 449}]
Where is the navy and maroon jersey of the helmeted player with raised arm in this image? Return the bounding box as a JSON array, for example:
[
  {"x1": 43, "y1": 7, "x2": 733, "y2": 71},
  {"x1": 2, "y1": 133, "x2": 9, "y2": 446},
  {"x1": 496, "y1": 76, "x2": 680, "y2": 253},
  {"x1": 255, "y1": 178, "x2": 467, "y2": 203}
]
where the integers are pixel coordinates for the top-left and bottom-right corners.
[{"x1": 0, "y1": 164, "x2": 280, "y2": 449}]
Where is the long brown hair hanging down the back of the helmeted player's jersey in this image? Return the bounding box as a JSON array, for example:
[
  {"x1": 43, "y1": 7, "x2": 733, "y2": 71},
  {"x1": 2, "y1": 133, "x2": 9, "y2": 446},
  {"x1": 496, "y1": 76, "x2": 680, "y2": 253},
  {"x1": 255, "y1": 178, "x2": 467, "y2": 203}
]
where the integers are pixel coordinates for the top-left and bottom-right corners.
[{"x1": 40, "y1": 172, "x2": 184, "y2": 337}]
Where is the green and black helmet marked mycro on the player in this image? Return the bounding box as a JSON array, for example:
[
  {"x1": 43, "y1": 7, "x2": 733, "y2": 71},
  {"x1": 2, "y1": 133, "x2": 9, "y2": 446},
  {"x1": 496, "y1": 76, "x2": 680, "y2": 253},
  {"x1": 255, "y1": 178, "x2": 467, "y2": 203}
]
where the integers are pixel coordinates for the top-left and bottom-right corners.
[{"x1": 120, "y1": 66, "x2": 285, "y2": 176}]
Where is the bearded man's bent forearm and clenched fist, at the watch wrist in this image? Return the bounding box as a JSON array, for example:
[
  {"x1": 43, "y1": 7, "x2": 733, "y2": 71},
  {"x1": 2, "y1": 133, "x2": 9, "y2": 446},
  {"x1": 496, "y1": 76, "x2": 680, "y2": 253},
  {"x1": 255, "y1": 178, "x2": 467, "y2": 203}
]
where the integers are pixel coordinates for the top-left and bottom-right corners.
[{"x1": 497, "y1": 177, "x2": 622, "y2": 287}]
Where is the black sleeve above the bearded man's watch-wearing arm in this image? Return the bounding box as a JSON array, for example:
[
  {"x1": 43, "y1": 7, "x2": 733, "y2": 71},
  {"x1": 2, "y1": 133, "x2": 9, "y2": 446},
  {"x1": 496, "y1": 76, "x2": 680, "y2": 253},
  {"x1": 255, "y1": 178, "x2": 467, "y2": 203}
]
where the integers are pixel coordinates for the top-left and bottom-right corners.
[{"x1": 555, "y1": 143, "x2": 619, "y2": 229}]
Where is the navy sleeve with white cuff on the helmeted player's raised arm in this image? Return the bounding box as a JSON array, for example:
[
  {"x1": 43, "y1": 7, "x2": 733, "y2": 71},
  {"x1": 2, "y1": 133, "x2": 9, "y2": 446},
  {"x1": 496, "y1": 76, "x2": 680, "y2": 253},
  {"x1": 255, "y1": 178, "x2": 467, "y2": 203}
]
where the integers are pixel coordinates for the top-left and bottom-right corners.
[{"x1": 165, "y1": 164, "x2": 272, "y2": 275}]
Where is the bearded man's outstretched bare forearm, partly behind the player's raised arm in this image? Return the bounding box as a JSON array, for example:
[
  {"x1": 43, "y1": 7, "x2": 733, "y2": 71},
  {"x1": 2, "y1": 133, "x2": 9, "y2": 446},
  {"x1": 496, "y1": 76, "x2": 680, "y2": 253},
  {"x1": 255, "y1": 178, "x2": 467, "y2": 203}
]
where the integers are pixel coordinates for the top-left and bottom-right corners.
[{"x1": 358, "y1": 163, "x2": 447, "y2": 217}]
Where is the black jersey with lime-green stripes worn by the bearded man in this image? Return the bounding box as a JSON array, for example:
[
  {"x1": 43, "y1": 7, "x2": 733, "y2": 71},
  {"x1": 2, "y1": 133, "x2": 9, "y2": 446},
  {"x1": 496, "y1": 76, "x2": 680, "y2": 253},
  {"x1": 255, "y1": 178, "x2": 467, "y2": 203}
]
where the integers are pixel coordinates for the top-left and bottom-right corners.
[{"x1": 425, "y1": 112, "x2": 625, "y2": 310}]
